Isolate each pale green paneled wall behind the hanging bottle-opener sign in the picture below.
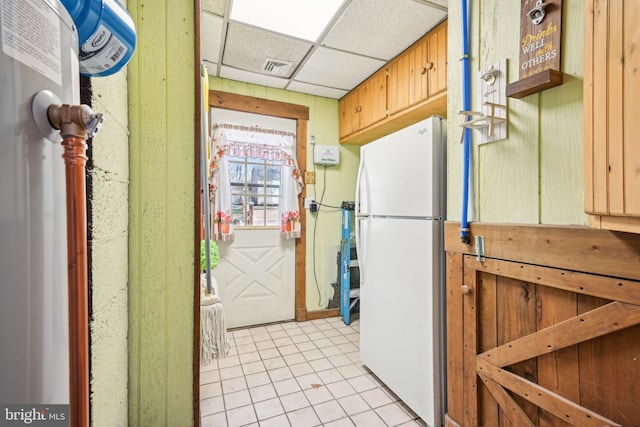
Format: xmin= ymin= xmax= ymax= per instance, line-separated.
xmin=447 ymin=0 xmax=587 ymax=224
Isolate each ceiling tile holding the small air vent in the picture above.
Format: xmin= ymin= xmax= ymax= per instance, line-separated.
xmin=222 ymin=22 xmax=311 ymax=77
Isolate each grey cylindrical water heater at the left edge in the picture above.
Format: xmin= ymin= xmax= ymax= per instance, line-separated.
xmin=0 ymin=0 xmax=80 ymax=405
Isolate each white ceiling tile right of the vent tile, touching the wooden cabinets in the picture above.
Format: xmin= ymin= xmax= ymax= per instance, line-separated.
xmin=295 ymin=47 xmax=385 ymax=90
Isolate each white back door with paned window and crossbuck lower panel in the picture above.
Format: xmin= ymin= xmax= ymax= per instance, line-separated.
xmin=210 ymin=108 xmax=298 ymax=329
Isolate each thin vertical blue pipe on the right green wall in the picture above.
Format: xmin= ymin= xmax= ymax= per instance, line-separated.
xmin=460 ymin=0 xmax=471 ymax=245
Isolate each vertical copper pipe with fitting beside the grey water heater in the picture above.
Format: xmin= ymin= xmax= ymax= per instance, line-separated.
xmin=47 ymin=104 xmax=101 ymax=427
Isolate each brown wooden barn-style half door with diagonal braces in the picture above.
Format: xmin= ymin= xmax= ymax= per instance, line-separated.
xmin=445 ymin=222 xmax=640 ymax=426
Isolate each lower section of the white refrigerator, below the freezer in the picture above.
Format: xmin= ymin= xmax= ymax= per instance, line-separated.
xmin=358 ymin=218 xmax=444 ymax=426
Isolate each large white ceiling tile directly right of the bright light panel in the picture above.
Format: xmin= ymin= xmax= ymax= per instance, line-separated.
xmin=323 ymin=0 xmax=447 ymax=61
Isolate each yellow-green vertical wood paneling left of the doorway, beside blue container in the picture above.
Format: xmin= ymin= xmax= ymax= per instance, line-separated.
xmin=128 ymin=0 xmax=195 ymax=426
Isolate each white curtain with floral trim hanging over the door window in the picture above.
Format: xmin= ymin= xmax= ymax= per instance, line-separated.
xmin=209 ymin=123 xmax=304 ymax=241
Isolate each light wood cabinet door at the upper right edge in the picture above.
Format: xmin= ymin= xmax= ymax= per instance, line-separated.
xmin=584 ymin=0 xmax=640 ymax=232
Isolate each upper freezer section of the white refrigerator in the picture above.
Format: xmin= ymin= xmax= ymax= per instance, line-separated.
xmin=356 ymin=118 xmax=446 ymax=217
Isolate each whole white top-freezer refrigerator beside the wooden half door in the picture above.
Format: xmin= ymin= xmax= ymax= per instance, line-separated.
xmin=355 ymin=116 xmax=446 ymax=426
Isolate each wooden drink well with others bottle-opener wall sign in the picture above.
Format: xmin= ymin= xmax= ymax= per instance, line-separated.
xmin=507 ymin=0 xmax=562 ymax=98
